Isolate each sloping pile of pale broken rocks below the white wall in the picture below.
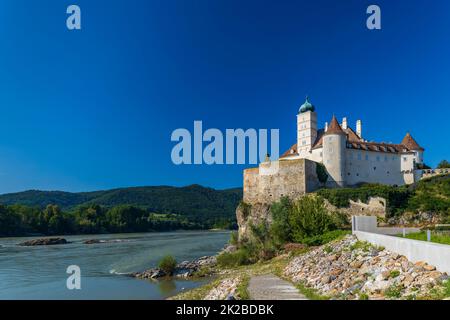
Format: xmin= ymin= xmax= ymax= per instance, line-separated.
xmin=284 ymin=236 xmax=448 ymax=299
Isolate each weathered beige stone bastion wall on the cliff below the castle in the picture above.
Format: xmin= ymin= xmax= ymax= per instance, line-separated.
xmin=244 ymin=159 xmax=320 ymax=204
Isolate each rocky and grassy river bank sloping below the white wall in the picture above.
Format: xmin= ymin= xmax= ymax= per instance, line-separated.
xmin=170 ymin=235 xmax=450 ymax=300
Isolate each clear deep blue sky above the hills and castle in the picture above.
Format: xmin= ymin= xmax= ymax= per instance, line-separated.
xmin=0 ymin=0 xmax=450 ymax=193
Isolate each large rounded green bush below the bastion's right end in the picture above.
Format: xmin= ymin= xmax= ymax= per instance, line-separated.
xmin=289 ymin=196 xmax=336 ymax=242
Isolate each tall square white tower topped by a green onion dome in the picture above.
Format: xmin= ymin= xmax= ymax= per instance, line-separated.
xmin=297 ymin=97 xmax=317 ymax=157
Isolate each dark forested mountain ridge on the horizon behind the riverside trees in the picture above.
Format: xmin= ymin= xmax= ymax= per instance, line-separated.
xmin=0 ymin=185 xmax=242 ymax=221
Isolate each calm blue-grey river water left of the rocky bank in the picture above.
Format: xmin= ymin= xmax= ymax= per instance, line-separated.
xmin=0 ymin=231 xmax=229 ymax=299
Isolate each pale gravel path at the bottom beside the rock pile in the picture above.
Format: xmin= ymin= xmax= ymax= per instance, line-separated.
xmin=248 ymin=274 xmax=308 ymax=300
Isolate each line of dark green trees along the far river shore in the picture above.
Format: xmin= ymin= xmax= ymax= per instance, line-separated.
xmin=0 ymin=204 xmax=236 ymax=237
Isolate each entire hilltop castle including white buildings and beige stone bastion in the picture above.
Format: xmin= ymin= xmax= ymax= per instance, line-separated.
xmin=244 ymin=98 xmax=424 ymax=203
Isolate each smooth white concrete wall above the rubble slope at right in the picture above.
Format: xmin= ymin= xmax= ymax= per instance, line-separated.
xmin=353 ymin=231 xmax=450 ymax=273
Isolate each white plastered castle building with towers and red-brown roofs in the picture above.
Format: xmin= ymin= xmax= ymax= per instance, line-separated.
xmin=281 ymin=100 xmax=424 ymax=186
